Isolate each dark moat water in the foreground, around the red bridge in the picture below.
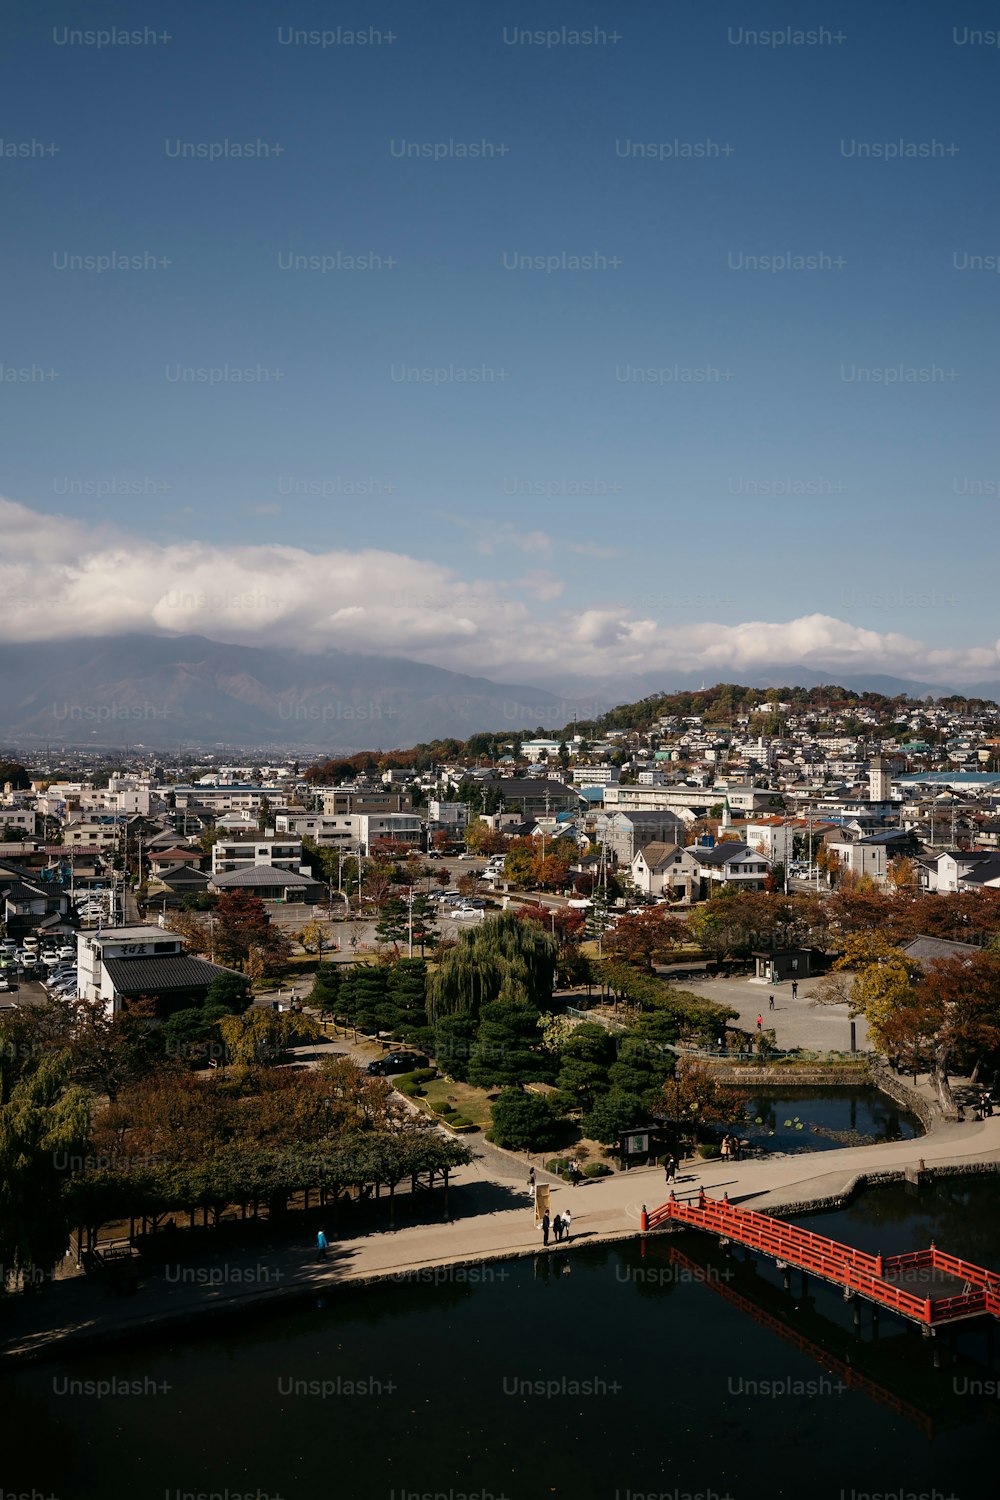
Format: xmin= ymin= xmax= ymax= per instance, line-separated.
xmin=0 ymin=1178 xmax=1000 ymax=1500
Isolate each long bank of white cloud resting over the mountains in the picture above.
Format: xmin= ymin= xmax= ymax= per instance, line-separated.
xmin=0 ymin=500 xmax=1000 ymax=683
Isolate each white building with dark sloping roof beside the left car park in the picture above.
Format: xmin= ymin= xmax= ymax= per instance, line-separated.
xmin=76 ymin=927 xmax=234 ymax=1017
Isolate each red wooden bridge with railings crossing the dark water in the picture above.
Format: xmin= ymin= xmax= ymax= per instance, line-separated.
xmin=640 ymin=1193 xmax=1000 ymax=1332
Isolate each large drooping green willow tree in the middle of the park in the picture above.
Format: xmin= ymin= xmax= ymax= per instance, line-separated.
xmin=427 ymin=912 xmax=558 ymax=1023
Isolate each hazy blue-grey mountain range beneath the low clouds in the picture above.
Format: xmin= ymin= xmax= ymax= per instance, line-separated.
xmin=0 ymin=635 xmax=1000 ymax=755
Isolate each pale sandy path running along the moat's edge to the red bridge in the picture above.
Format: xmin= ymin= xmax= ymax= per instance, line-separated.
xmin=3 ymin=1098 xmax=1000 ymax=1355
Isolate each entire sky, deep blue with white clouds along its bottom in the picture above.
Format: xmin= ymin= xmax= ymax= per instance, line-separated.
xmin=0 ymin=0 xmax=1000 ymax=681
